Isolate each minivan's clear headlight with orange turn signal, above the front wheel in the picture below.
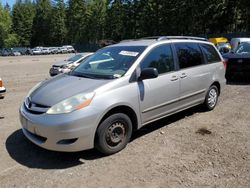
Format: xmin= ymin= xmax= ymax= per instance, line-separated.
xmin=47 ymin=92 xmax=95 ymax=114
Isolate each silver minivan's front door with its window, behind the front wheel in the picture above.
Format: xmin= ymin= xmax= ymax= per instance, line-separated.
xmin=138 ymin=44 xmax=180 ymax=124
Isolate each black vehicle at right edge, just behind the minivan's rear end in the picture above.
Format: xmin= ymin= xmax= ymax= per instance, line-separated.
xmin=223 ymin=41 xmax=250 ymax=80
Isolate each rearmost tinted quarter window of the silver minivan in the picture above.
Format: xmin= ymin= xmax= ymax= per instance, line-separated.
xmin=201 ymin=44 xmax=221 ymax=63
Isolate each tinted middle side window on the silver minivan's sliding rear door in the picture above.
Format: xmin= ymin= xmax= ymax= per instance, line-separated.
xmin=175 ymin=43 xmax=203 ymax=69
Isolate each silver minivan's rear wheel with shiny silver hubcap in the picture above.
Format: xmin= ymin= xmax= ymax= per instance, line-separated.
xmin=203 ymin=85 xmax=219 ymax=111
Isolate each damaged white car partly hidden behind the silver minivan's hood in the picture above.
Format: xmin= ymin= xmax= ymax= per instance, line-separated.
xmin=49 ymin=53 xmax=93 ymax=76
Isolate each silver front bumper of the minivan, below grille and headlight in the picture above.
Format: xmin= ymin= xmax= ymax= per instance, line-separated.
xmin=20 ymin=102 xmax=100 ymax=152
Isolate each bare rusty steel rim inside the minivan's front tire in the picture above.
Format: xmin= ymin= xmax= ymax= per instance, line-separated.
xmin=106 ymin=122 xmax=126 ymax=147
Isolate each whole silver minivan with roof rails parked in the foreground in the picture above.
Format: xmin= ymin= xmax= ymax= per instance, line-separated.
xmin=20 ymin=37 xmax=226 ymax=154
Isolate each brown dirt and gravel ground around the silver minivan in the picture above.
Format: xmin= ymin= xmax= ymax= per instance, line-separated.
xmin=0 ymin=55 xmax=250 ymax=188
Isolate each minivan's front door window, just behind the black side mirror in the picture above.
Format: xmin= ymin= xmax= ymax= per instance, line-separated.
xmin=141 ymin=45 xmax=174 ymax=74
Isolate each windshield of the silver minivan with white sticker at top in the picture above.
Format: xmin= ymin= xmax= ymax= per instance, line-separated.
xmin=71 ymin=46 xmax=146 ymax=79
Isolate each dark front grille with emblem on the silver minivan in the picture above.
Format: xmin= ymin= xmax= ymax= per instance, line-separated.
xmin=24 ymin=97 xmax=50 ymax=115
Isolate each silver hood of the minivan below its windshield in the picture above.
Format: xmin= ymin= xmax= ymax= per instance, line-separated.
xmin=30 ymin=74 xmax=112 ymax=106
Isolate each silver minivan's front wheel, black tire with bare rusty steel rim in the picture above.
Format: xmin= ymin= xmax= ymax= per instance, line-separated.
xmin=95 ymin=113 xmax=132 ymax=155
